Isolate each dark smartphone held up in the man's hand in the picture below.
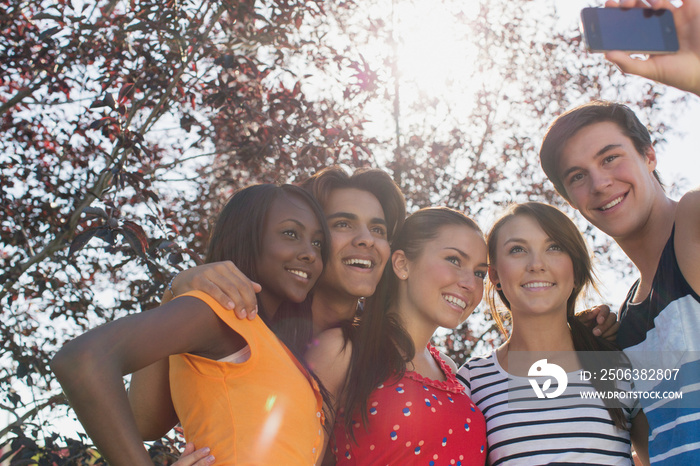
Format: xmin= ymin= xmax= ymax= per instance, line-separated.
xmin=581 ymin=8 xmax=678 ymax=54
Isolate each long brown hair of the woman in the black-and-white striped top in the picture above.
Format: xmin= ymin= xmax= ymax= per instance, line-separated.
xmin=486 ymin=202 xmax=629 ymax=430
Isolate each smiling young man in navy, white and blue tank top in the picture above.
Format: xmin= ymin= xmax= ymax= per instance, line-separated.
xmin=540 ymin=101 xmax=700 ymax=464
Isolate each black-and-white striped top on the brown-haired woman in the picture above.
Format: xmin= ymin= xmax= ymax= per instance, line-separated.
xmin=457 ymin=353 xmax=639 ymax=466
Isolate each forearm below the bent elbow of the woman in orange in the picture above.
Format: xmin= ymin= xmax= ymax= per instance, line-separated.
xmin=51 ymin=342 xmax=153 ymax=466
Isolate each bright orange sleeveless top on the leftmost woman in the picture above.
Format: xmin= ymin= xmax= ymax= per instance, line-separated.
xmin=170 ymin=292 xmax=323 ymax=465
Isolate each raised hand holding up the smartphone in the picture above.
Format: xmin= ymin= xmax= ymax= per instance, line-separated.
xmin=605 ymin=0 xmax=700 ymax=96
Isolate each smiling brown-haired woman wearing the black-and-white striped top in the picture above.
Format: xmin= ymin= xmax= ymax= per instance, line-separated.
xmin=458 ymin=202 xmax=646 ymax=466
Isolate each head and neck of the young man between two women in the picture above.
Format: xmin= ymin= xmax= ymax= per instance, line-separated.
xmin=301 ymin=166 xmax=406 ymax=334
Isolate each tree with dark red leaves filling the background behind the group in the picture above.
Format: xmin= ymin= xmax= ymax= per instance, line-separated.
xmin=0 ymin=0 xmax=688 ymax=464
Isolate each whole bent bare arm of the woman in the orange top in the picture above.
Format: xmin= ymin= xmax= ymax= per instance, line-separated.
xmin=51 ymin=297 xmax=238 ymax=466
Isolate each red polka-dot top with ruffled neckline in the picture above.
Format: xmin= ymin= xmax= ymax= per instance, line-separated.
xmin=331 ymin=345 xmax=486 ymax=466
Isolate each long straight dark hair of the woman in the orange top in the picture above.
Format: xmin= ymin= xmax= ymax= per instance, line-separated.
xmin=206 ymin=184 xmax=330 ymax=355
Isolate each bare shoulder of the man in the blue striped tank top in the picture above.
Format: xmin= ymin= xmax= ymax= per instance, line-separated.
xmin=674 ymin=188 xmax=700 ymax=293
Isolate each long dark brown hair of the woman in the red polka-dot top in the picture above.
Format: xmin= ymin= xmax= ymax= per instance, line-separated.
xmin=343 ymin=207 xmax=482 ymax=437
